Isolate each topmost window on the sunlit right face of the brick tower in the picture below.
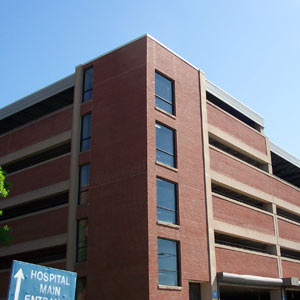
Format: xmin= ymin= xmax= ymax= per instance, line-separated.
xmin=155 ymin=72 xmax=174 ymax=114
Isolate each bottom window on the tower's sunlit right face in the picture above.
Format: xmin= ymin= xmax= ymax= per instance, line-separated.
xmin=157 ymin=238 xmax=180 ymax=286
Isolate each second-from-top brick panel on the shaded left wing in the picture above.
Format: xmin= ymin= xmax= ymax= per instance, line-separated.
xmin=7 ymin=155 xmax=70 ymax=197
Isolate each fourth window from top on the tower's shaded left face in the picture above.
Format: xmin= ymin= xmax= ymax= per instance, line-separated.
xmin=76 ymin=218 xmax=88 ymax=262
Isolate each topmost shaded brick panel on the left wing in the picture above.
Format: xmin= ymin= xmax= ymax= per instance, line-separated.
xmin=0 ymin=107 xmax=72 ymax=156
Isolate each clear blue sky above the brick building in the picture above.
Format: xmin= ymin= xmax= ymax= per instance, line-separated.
xmin=0 ymin=0 xmax=300 ymax=158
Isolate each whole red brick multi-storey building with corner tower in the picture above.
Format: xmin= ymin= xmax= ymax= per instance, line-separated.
xmin=0 ymin=35 xmax=300 ymax=300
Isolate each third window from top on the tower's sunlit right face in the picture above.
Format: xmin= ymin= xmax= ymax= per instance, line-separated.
xmin=156 ymin=178 xmax=177 ymax=224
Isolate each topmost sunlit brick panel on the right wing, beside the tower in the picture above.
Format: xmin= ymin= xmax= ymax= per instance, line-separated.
xmin=207 ymin=102 xmax=267 ymax=154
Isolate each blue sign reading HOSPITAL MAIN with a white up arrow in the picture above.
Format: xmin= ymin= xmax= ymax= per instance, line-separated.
xmin=7 ymin=260 xmax=77 ymax=300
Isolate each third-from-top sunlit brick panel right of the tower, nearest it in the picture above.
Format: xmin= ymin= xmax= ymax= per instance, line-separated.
xmin=213 ymin=196 xmax=274 ymax=235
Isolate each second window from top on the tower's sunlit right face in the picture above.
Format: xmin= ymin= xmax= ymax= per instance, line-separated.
xmin=155 ymin=123 xmax=176 ymax=167
